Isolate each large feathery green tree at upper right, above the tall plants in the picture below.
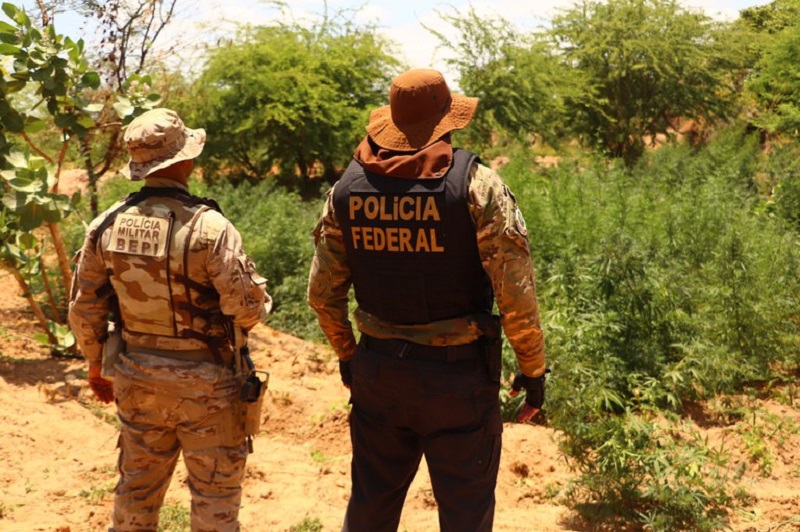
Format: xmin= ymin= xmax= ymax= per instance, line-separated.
xmin=551 ymin=0 xmax=737 ymax=165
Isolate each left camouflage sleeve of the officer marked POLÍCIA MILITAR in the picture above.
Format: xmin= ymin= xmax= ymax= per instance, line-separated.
xmin=68 ymin=219 xmax=114 ymax=364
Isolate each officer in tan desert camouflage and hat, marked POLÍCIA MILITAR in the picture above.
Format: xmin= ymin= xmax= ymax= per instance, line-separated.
xmin=69 ymin=109 xmax=271 ymax=532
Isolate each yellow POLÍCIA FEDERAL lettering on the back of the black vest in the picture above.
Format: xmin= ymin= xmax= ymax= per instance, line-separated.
xmin=347 ymin=193 xmax=445 ymax=253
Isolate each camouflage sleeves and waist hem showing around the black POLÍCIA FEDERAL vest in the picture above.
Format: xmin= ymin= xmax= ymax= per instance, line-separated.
xmin=308 ymin=164 xmax=545 ymax=377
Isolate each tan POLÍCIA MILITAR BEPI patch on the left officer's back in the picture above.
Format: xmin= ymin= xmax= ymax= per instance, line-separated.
xmin=106 ymin=213 xmax=170 ymax=259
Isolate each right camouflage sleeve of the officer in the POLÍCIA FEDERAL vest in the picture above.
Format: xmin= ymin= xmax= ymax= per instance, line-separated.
xmin=469 ymin=165 xmax=545 ymax=377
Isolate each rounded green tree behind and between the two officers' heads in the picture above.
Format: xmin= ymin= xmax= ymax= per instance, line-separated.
xmin=190 ymin=9 xmax=399 ymax=190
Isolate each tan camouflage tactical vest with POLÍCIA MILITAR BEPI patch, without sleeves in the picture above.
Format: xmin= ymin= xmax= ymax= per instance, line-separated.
xmin=92 ymin=187 xmax=227 ymax=351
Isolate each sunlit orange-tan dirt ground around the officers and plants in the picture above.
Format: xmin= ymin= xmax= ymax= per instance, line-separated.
xmin=0 ymin=172 xmax=800 ymax=532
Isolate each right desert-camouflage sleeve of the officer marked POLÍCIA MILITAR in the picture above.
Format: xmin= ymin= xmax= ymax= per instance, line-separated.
xmin=204 ymin=215 xmax=272 ymax=330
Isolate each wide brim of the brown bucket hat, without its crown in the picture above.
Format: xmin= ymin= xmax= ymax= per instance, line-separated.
xmin=366 ymin=94 xmax=478 ymax=151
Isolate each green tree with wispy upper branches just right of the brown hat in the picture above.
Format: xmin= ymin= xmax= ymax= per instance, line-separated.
xmin=427 ymin=8 xmax=573 ymax=152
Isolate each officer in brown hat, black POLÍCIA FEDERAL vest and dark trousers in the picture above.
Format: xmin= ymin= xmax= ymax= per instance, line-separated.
xmin=308 ymin=69 xmax=545 ymax=532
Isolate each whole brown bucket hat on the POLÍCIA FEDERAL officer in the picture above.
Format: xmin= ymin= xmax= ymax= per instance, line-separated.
xmin=367 ymin=68 xmax=478 ymax=151
